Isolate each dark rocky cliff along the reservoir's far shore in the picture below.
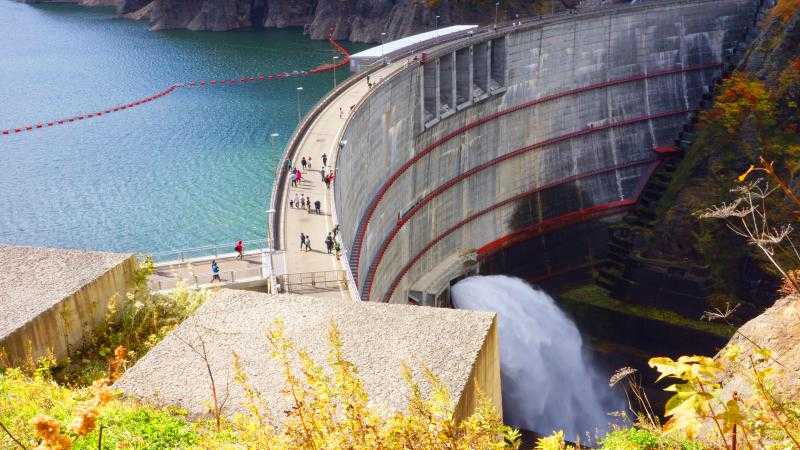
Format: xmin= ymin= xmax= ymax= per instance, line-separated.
xmin=22 ymin=0 xmax=571 ymax=42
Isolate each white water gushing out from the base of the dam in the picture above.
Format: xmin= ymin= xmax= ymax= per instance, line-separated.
xmin=452 ymin=275 xmax=624 ymax=442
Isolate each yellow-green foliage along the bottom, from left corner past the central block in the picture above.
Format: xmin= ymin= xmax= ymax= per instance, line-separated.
xmin=0 ymin=322 xmax=519 ymax=450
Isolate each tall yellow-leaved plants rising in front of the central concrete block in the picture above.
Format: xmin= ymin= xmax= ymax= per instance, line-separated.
xmin=256 ymin=321 xmax=519 ymax=450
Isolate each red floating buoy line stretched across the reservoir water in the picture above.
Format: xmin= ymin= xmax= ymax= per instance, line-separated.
xmin=0 ymin=36 xmax=350 ymax=136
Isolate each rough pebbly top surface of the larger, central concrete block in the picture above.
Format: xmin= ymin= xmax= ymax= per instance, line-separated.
xmin=116 ymin=289 xmax=494 ymax=423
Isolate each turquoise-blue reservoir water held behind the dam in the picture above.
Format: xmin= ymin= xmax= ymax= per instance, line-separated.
xmin=0 ymin=0 xmax=366 ymax=252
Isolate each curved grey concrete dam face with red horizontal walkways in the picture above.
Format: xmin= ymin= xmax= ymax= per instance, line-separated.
xmin=335 ymin=0 xmax=760 ymax=302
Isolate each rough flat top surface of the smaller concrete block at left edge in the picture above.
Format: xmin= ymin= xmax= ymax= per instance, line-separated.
xmin=0 ymin=244 xmax=131 ymax=340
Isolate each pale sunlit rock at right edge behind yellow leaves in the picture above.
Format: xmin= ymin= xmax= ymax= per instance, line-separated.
xmin=722 ymin=295 xmax=800 ymax=399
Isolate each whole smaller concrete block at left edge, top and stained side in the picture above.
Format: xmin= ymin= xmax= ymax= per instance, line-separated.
xmin=0 ymin=245 xmax=136 ymax=366
